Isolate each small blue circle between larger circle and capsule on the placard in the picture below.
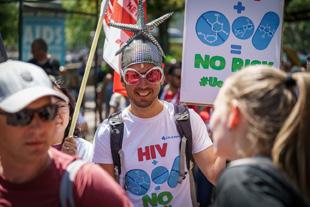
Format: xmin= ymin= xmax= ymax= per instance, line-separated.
xmin=231 ymin=16 xmax=254 ymax=40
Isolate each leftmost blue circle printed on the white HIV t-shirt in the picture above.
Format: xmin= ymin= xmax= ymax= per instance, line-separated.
xmin=125 ymin=170 xmax=151 ymax=196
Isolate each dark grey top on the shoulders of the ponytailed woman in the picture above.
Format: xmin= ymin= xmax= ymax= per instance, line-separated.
xmin=216 ymin=158 xmax=308 ymax=206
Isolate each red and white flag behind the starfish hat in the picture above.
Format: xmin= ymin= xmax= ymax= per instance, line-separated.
xmin=101 ymin=0 xmax=146 ymax=95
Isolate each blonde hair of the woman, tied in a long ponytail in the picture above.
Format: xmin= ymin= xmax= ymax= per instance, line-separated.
xmin=220 ymin=65 xmax=310 ymax=202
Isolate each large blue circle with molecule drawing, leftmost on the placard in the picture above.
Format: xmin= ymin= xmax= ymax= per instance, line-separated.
xmin=196 ymin=11 xmax=230 ymax=46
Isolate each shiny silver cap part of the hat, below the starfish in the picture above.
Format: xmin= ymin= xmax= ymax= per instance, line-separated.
xmin=122 ymin=39 xmax=163 ymax=70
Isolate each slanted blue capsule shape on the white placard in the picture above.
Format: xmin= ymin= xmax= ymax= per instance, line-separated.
xmin=252 ymin=12 xmax=280 ymax=50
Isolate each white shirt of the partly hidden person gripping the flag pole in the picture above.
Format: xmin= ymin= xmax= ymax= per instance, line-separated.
xmin=75 ymin=138 xmax=93 ymax=162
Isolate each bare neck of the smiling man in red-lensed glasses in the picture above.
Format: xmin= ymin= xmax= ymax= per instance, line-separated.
xmin=129 ymin=99 xmax=164 ymax=118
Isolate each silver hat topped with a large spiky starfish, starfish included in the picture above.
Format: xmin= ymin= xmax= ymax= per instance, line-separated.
xmin=110 ymin=0 xmax=173 ymax=69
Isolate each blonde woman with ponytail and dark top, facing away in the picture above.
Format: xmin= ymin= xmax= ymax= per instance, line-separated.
xmin=211 ymin=66 xmax=310 ymax=207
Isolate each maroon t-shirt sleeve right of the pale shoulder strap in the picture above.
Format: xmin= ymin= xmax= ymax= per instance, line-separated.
xmin=74 ymin=163 xmax=132 ymax=207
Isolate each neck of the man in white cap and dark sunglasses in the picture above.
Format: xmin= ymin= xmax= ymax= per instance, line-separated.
xmin=0 ymin=153 xmax=51 ymax=183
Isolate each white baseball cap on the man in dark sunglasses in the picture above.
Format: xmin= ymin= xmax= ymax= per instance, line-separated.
xmin=0 ymin=60 xmax=68 ymax=113
